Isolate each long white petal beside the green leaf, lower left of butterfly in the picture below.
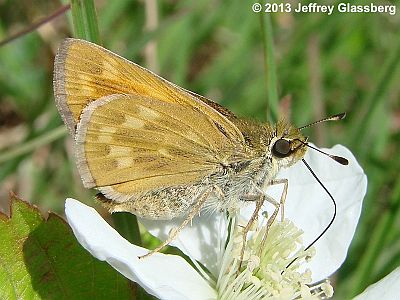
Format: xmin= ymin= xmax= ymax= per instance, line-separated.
xmin=65 ymin=199 xmax=216 ymax=300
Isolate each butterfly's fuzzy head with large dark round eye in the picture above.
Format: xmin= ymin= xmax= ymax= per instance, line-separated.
xmin=269 ymin=120 xmax=307 ymax=168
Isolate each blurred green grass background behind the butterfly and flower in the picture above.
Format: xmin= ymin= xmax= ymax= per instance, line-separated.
xmin=0 ymin=0 xmax=400 ymax=299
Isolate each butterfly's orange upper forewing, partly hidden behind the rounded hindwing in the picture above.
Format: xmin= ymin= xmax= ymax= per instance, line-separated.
xmin=54 ymin=39 xmax=243 ymax=141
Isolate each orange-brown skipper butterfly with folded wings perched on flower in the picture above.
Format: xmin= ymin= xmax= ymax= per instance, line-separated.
xmin=54 ymin=39 xmax=344 ymax=258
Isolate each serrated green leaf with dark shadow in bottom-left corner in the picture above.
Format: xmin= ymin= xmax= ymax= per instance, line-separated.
xmin=0 ymin=198 xmax=133 ymax=300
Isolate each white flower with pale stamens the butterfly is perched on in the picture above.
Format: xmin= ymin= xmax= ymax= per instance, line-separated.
xmin=65 ymin=146 xmax=367 ymax=300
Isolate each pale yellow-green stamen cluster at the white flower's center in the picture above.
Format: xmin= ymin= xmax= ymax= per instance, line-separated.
xmin=216 ymin=219 xmax=333 ymax=300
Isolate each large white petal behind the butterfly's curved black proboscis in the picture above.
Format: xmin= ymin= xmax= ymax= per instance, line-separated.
xmin=244 ymin=145 xmax=367 ymax=282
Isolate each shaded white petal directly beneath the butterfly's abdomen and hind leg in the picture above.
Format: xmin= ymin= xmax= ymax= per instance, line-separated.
xmin=139 ymin=213 xmax=227 ymax=276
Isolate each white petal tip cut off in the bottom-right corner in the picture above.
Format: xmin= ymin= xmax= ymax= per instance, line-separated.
xmin=353 ymin=267 xmax=400 ymax=300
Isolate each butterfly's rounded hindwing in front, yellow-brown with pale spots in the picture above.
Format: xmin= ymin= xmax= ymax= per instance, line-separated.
xmin=76 ymin=94 xmax=243 ymax=200
